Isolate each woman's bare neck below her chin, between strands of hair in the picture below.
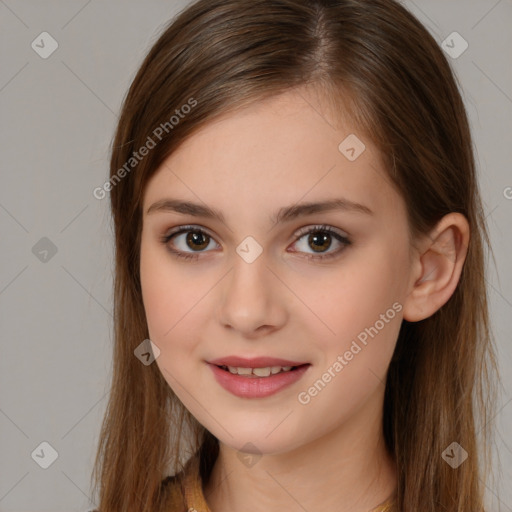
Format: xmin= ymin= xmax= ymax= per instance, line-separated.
xmin=204 ymin=390 xmax=396 ymax=512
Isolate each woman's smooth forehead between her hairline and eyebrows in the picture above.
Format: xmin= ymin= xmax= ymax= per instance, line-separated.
xmin=144 ymin=90 xmax=396 ymax=221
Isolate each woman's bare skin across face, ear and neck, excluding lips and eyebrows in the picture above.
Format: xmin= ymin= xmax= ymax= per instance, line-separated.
xmin=140 ymin=87 xmax=469 ymax=512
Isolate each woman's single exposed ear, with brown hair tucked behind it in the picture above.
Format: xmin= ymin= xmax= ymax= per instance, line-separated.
xmin=403 ymin=213 xmax=469 ymax=322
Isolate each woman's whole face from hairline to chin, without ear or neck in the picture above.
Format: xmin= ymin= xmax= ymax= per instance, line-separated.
xmin=140 ymin=86 xmax=411 ymax=453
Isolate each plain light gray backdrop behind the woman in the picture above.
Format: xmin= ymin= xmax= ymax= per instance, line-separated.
xmin=0 ymin=0 xmax=512 ymax=512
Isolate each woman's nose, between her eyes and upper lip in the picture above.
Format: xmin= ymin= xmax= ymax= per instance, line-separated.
xmin=217 ymin=250 xmax=289 ymax=339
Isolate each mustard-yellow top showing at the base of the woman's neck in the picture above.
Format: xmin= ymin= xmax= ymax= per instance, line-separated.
xmin=163 ymin=456 xmax=395 ymax=512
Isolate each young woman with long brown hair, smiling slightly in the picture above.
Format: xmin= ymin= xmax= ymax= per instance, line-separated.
xmin=90 ymin=0 xmax=495 ymax=512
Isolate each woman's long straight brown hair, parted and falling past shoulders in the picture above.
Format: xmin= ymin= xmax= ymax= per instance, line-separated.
xmin=93 ymin=0 xmax=496 ymax=512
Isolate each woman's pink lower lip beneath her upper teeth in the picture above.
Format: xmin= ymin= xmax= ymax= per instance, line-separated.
xmin=209 ymin=364 xmax=311 ymax=398
